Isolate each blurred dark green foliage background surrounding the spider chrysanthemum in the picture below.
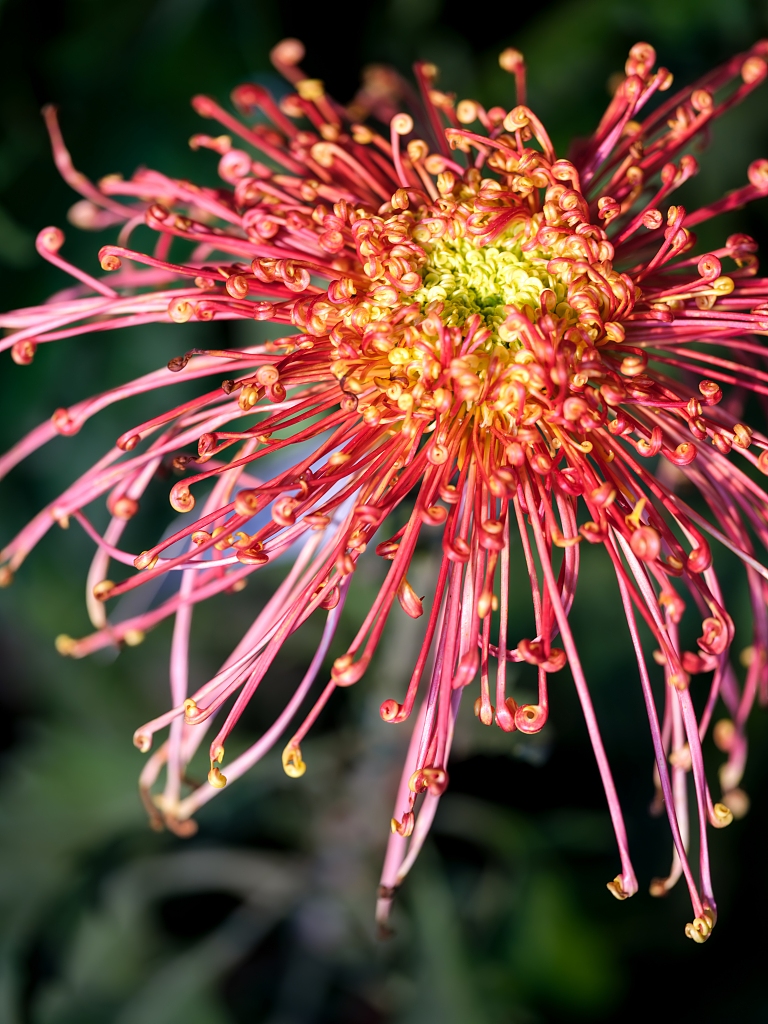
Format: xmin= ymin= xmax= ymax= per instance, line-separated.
xmin=0 ymin=0 xmax=768 ymax=1024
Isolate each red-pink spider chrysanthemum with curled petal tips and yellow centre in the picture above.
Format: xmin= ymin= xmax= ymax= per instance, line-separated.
xmin=0 ymin=40 xmax=768 ymax=942
